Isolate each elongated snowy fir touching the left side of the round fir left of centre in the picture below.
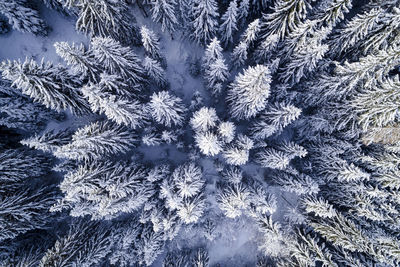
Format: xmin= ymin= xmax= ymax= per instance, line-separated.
xmin=81 ymin=81 xmax=148 ymax=129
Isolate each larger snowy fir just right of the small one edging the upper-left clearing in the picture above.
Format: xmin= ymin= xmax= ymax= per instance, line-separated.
xmin=90 ymin=37 xmax=145 ymax=85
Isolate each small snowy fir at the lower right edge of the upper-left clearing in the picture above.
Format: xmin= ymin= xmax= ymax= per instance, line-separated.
xmin=54 ymin=42 xmax=100 ymax=81
